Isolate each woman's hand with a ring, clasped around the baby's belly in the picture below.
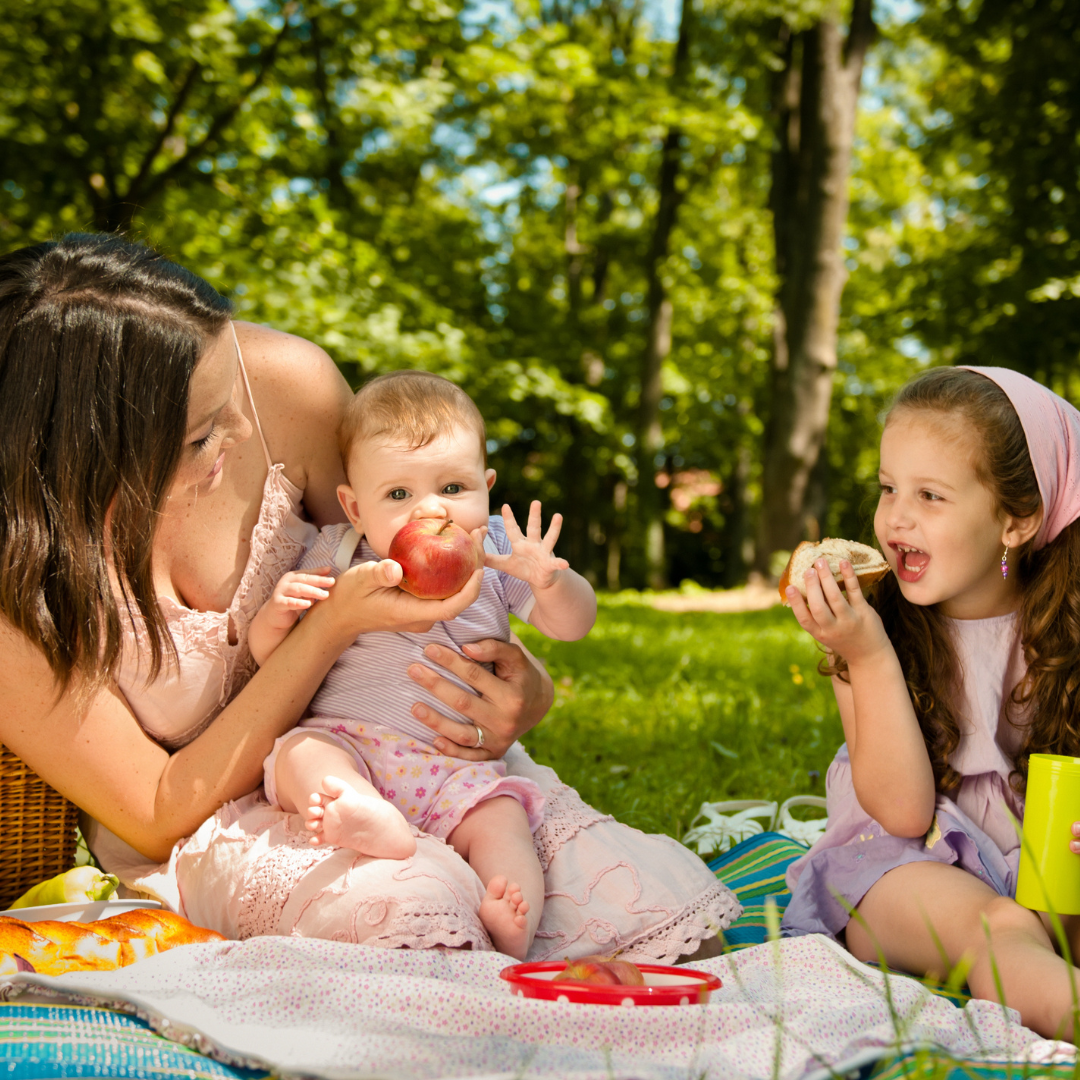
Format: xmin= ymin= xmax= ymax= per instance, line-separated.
xmin=408 ymin=639 xmax=555 ymax=761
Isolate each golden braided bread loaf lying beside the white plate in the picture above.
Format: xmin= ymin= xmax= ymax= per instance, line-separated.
xmin=0 ymin=908 xmax=225 ymax=975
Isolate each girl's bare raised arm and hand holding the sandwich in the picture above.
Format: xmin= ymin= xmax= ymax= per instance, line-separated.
xmin=787 ymin=561 xmax=936 ymax=837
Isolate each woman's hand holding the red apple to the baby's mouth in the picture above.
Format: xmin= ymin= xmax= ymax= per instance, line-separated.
xmin=309 ymin=558 xmax=484 ymax=642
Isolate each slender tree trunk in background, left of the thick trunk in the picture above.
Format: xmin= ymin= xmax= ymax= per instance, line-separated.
xmin=637 ymin=0 xmax=693 ymax=589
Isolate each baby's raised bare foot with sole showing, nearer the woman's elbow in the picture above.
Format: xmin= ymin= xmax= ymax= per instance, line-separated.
xmin=303 ymin=777 xmax=416 ymax=859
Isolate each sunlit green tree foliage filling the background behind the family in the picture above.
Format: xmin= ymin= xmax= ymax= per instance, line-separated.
xmin=0 ymin=0 xmax=1080 ymax=588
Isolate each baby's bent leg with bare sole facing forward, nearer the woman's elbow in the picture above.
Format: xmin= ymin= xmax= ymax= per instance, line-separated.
xmin=274 ymin=731 xmax=416 ymax=859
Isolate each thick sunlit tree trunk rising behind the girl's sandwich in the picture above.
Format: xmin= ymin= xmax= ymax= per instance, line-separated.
xmin=755 ymin=0 xmax=874 ymax=572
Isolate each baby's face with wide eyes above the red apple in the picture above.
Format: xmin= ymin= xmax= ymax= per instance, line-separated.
xmin=338 ymin=427 xmax=495 ymax=558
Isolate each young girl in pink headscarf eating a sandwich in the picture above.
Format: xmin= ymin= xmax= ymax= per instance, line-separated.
xmin=783 ymin=368 xmax=1080 ymax=1038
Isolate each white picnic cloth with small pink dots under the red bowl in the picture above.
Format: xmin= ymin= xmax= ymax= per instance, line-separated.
xmin=3 ymin=936 xmax=1074 ymax=1080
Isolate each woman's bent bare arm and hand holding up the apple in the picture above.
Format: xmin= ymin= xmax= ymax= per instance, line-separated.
xmin=0 ymin=561 xmax=483 ymax=861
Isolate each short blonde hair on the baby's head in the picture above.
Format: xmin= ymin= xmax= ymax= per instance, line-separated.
xmin=338 ymin=372 xmax=487 ymax=468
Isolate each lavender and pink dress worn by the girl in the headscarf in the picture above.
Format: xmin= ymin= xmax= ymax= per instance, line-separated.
xmin=782 ymin=615 xmax=1025 ymax=937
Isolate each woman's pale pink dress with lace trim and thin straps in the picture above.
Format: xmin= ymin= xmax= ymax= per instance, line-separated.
xmin=84 ymin=330 xmax=740 ymax=962
